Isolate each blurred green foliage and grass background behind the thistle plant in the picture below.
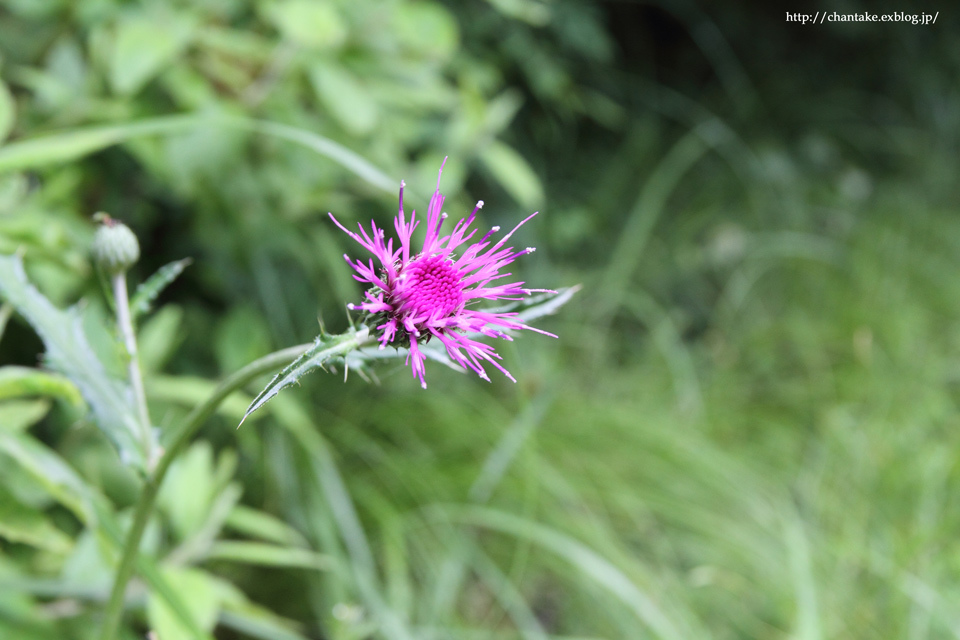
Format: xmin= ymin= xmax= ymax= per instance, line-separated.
xmin=0 ymin=0 xmax=960 ymax=640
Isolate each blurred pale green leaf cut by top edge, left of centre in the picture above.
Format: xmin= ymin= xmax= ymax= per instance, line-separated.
xmin=264 ymin=0 xmax=348 ymax=49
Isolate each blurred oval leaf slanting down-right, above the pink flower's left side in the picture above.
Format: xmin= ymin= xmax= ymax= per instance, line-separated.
xmin=310 ymin=62 xmax=377 ymax=136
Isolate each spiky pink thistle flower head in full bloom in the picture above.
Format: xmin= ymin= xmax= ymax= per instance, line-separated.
xmin=329 ymin=158 xmax=557 ymax=389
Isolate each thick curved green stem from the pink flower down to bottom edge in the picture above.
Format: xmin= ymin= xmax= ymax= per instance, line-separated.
xmin=100 ymin=342 xmax=313 ymax=640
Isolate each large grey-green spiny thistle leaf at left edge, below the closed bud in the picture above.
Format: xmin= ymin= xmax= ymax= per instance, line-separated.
xmin=0 ymin=256 xmax=159 ymax=469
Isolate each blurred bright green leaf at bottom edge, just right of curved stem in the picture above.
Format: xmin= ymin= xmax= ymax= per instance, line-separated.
xmin=147 ymin=567 xmax=221 ymax=640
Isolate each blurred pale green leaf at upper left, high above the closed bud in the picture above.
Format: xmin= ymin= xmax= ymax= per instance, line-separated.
xmin=110 ymin=13 xmax=193 ymax=95
